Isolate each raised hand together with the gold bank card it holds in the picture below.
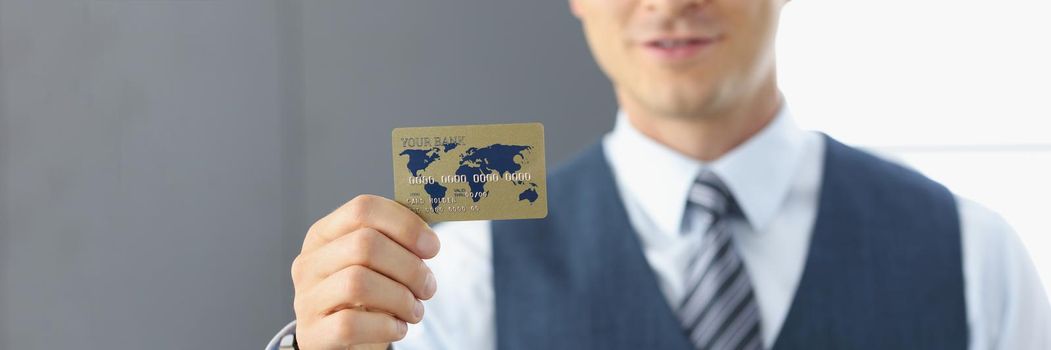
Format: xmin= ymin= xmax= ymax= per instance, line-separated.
xmin=292 ymin=123 xmax=548 ymax=349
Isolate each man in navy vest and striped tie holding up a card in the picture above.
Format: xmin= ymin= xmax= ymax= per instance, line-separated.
xmin=270 ymin=0 xmax=1051 ymax=350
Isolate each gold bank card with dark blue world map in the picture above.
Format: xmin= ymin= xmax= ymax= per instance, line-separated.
xmin=391 ymin=123 xmax=548 ymax=222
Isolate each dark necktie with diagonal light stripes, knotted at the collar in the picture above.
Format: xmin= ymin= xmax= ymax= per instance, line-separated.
xmin=678 ymin=172 xmax=762 ymax=350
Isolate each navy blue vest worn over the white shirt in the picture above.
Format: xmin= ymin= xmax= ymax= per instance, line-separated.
xmin=492 ymin=137 xmax=968 ymax=350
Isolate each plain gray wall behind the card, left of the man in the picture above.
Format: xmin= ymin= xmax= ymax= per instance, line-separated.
xmin=0 ymin=0 xmax=615 ymax=350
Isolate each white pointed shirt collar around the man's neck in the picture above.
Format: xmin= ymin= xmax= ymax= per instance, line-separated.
xmin=603 ymin=107 xmax=805 ymax=233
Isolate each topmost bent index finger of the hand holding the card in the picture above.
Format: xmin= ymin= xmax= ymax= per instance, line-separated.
xmin=302 ymin=194 xmax=440 ymax=259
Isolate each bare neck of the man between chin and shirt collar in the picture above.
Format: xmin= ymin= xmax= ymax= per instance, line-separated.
xmin=618 ymin=77 xmax=781 ymax=162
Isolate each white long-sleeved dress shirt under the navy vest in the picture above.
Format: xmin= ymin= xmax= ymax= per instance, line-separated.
xmin=270 ymin=108 xmax=1051 ymax=350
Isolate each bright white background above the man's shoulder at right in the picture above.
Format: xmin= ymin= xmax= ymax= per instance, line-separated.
xmin=778 ymin=0 xmax=1051 ymax=297
